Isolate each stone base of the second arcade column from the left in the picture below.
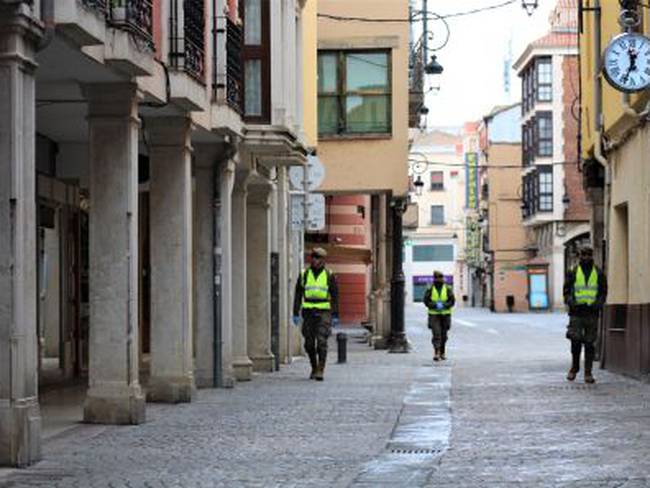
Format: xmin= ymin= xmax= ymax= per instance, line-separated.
xmin=84 ymin=386 xmax=145 ymax=425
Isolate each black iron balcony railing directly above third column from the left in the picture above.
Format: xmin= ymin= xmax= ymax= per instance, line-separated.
xmin=169 ymin=0 xmax=205 ymax=83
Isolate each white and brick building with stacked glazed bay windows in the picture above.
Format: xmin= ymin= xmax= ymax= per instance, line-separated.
xmin=514 ymin=0 xmax=590 ymax=310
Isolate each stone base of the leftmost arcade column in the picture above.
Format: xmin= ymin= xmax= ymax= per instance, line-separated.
xmin=0 ymin=398 xmax=41 ymax=468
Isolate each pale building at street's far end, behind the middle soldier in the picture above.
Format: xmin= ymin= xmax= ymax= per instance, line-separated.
xmin=404 ymin=128 xmax=467 ymax=304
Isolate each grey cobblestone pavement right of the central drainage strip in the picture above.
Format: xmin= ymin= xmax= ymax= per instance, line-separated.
xmin=428 ymin=312 xmax=650 ymax=488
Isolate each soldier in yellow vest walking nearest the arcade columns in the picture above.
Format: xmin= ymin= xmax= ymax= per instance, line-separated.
xmin=293 ymin=248 xmax=339 ymax=381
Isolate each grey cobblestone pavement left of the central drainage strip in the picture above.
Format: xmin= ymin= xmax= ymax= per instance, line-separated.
xmin=0 ymin=316 xmax=436 ymax=488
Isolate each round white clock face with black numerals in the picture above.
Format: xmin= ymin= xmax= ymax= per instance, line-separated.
xmin=603 ymin=33 xmax=650 ymax=92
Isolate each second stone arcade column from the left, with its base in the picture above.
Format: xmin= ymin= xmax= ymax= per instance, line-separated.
xmin=84 ymin=83 xmax=145 ymax=424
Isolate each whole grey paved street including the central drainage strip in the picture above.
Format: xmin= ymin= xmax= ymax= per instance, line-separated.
xmin=0 ymin=307 xmax=650 ymax=488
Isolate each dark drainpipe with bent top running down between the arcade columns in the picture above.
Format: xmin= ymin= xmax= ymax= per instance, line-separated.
xmin=212 ymin=139 xmax=237 ymax=388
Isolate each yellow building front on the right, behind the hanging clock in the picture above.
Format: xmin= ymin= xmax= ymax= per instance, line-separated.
xmin=580 ymin=0 xmax=650 ymax=376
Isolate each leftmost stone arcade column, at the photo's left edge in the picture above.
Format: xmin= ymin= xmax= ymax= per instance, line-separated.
xmin=0 ymin=2 xmax=42 ymax=467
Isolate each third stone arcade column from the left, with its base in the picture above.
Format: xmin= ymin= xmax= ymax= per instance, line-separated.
xmin=147 ymin=117 xmax=195 ymax=403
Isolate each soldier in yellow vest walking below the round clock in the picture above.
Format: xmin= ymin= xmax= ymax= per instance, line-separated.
xmin=564 ymin=247 xmax=607 ymax=384
